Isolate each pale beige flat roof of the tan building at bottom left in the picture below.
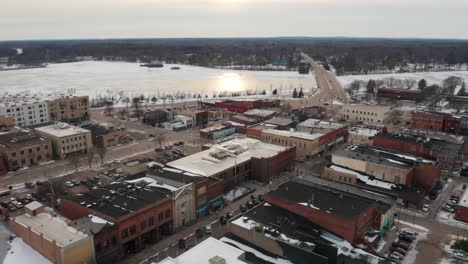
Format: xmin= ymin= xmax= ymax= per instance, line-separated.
xmin=14 ymin=213 xmax=88 ymax=247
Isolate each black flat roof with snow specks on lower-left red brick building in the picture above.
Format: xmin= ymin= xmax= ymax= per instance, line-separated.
xmin=70 ymin=182 xmax=172 ymax=219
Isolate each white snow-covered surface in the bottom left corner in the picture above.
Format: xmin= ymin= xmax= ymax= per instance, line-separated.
xmin=3 ymin=237 xmax=52 ymax=264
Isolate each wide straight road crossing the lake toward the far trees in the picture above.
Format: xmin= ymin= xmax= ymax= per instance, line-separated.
xmin=302 ymin=53 xmax=348 ymax=102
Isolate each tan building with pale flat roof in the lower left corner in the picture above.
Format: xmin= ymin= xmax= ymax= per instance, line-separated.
xmin=10 ymin=202 xmax=95 ymax=264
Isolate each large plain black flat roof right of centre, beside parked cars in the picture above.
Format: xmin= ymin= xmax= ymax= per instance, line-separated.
xmin=267 ymin=181 xmax=374 ymax=220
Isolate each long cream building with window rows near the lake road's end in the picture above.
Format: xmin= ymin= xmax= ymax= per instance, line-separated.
xmin=340 ymin=104 xmax=392 ymax=124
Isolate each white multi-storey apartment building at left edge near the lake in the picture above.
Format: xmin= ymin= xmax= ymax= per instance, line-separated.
xmin=0 ymin=97 xmax=49 ymax=127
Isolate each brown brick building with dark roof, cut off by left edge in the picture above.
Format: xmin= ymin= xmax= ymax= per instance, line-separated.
xmin=0 ymin=131 xmax=53 ymax=171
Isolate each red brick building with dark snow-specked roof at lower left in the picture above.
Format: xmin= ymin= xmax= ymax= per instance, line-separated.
xmin=61 ymin=182 xmax=173 ymax=259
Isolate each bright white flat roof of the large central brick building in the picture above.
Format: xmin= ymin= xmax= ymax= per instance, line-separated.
xmin=167 ymin=138 xmax=288 ymax=176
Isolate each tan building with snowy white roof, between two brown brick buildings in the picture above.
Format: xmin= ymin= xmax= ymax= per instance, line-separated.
xmin=35 ymin=123 xmax=92 ymax=159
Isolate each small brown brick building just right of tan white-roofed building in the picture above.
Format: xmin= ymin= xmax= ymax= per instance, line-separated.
xmin=81 ymin=123 xmax=129 ymax=148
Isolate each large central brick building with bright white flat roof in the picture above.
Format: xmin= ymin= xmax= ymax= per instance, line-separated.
xmin=167 ymin=138 xmax=296 ymax=189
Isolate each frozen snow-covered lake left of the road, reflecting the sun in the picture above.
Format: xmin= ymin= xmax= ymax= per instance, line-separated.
xmin=0 ymin=61 xmax=316 ymax=97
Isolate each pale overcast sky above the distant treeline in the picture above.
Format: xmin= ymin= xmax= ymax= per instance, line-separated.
xmin=0 ymin=0 xmax=468 ymax=40
